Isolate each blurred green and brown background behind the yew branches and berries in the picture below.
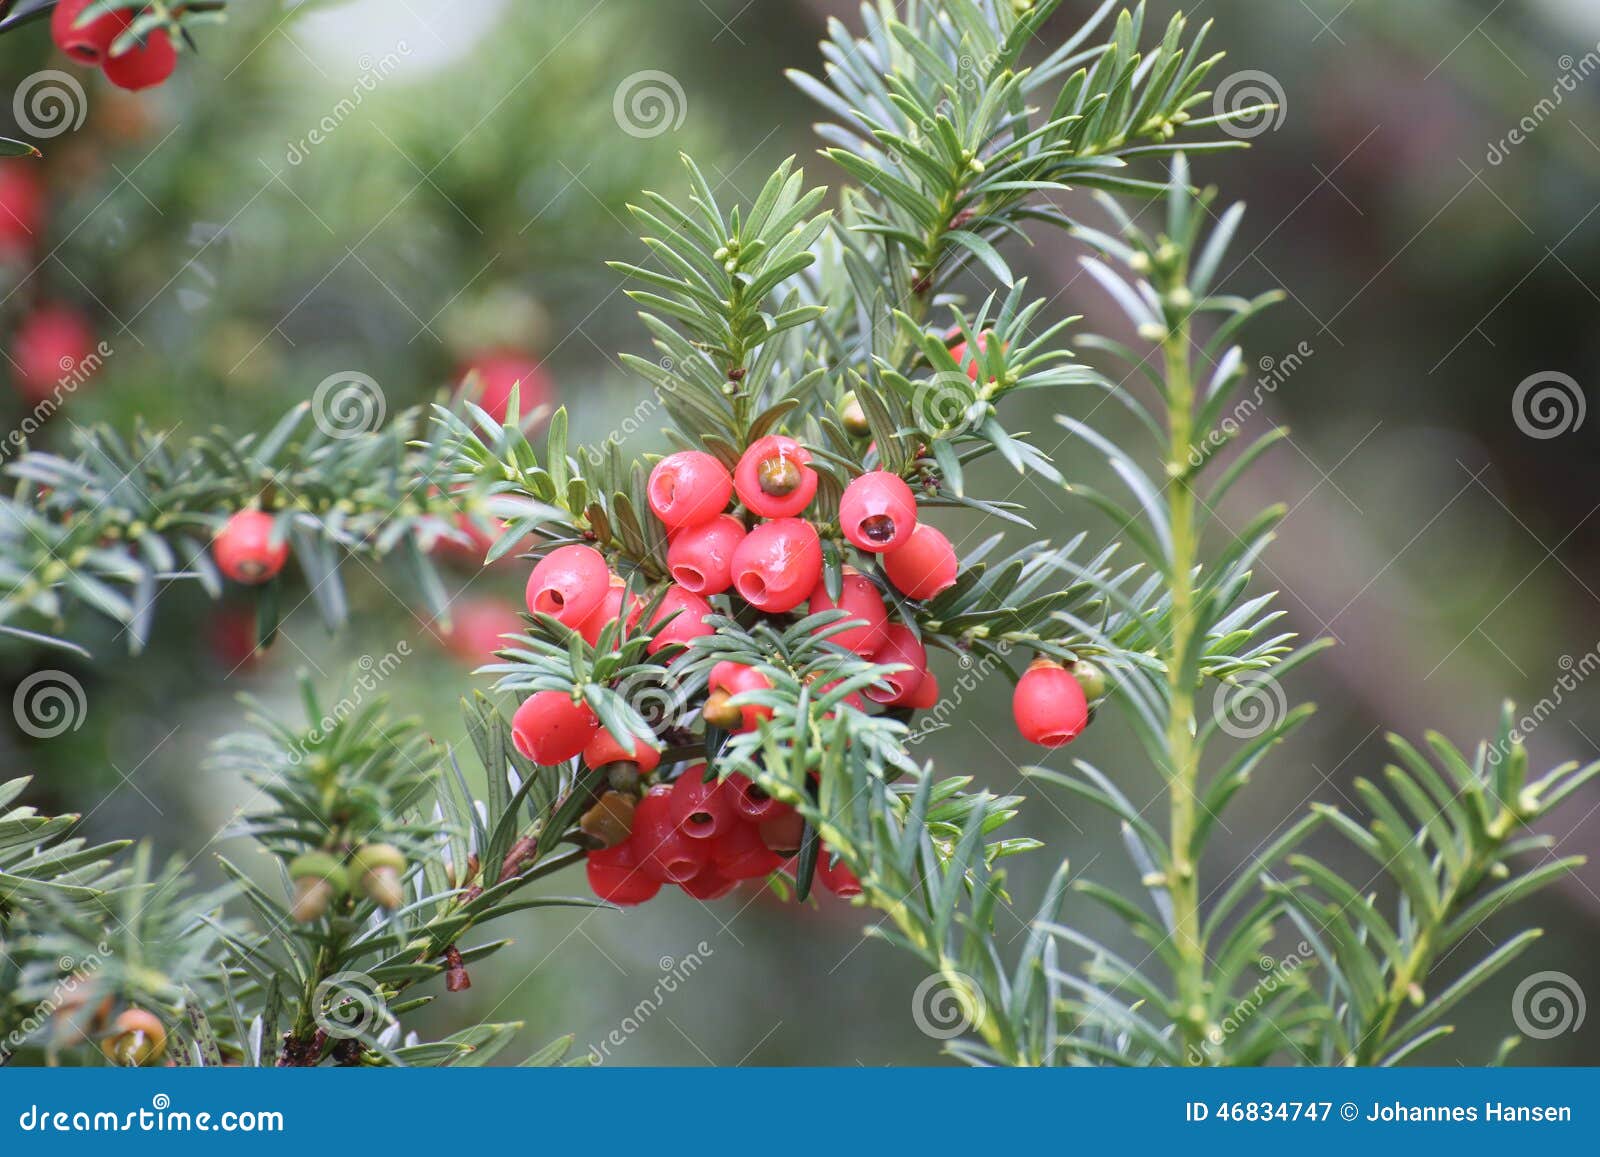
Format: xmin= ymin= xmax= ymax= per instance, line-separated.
xmin=0 ymin=0 xmax=1600 ymax=1064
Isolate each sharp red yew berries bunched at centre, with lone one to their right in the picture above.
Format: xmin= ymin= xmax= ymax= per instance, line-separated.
xmin=512 ymin=434 xmax=1104 ymax=904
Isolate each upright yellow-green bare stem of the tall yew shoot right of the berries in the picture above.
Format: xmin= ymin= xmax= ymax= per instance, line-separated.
xmin=1163 ymin=322 xmax=1208 ymax=1059
